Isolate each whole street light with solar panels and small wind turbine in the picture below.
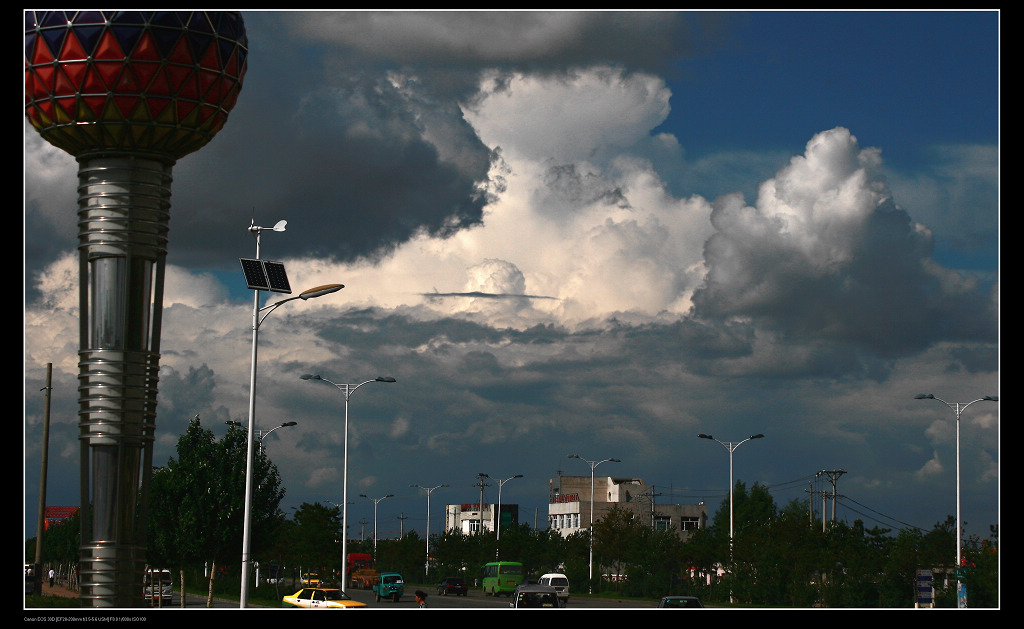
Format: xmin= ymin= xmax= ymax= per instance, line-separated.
xmin=239 ymin=220 xmax=345 ymax=607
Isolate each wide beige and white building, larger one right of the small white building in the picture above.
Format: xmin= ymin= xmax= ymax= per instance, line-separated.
xmin=548 ymin=476 xmax=708 ymax=539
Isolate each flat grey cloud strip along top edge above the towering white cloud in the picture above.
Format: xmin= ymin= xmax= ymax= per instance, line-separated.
xmin=283 ymin=11 xmax=724 ymax=89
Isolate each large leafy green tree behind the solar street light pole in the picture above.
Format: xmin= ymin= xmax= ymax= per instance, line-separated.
xmin=146 ymin=415 xmax=285 ymax=593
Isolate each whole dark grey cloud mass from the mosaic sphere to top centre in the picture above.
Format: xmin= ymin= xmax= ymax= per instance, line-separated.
xmin=157 ymin=11 xmax=719 ymax=267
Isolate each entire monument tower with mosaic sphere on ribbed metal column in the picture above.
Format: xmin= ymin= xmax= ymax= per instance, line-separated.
xmin=25 ymin=11 xmax=249 ymax=607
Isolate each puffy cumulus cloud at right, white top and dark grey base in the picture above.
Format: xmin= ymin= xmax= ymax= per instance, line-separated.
xmin=694 ymin=128 xmax=995 ymax=355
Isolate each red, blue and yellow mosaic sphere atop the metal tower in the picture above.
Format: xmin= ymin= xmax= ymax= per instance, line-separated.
xmin=25 ymin=11 xmax=249 ymax=160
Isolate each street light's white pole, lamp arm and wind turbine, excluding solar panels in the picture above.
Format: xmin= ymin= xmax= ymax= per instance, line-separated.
xmin=239 ymin=220 xmax=345 ymax=607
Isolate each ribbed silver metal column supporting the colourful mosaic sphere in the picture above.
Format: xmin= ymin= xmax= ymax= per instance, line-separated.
xmin=78 ymin=154 xmax=173 ymax=607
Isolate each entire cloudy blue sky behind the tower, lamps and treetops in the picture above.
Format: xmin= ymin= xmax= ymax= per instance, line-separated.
xmin=25 ymin=11 xmax=999 ymax=549
